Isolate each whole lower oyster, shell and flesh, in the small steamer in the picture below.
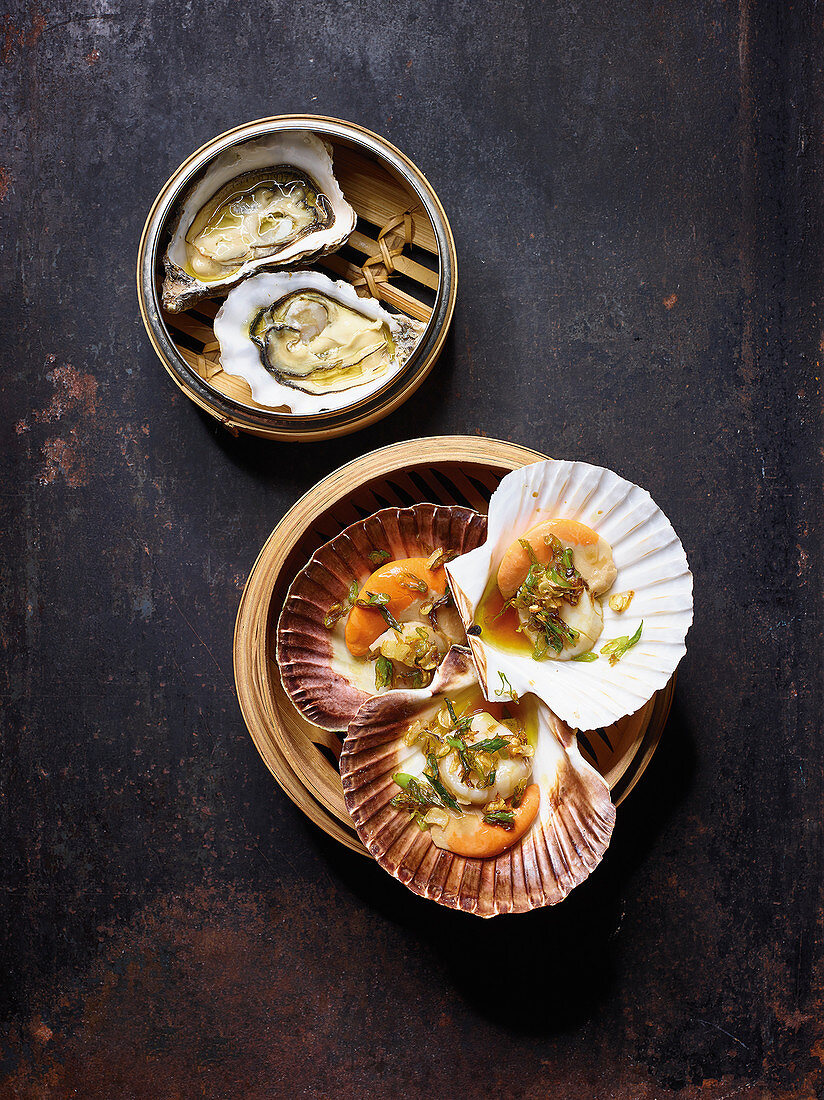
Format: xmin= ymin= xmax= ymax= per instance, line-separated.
xmin=215 ymin=271 xmax=426 ymax=415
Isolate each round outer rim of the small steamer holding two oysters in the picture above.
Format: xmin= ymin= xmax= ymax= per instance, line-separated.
xmin=136 ymin=114 xmax=458 ymax=442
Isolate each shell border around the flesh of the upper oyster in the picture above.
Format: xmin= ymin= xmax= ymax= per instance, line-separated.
xmin=163 ymin=130 xmax=356 ymax=314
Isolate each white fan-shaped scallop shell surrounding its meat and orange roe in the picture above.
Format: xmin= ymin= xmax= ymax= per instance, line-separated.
xmin=447 ymin=459 xmax=692 ymax=729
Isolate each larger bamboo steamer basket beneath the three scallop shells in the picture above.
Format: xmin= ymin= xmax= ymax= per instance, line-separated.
xmin=234 ymin=436 xmax=674 ymax=855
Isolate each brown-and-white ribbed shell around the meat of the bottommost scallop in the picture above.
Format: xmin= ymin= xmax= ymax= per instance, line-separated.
xmin=340 ymin=646 xmax=615 ymax=916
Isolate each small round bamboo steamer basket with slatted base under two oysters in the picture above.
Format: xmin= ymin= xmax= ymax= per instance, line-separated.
xmin=138 ymin=114 xmax=458 ymax=442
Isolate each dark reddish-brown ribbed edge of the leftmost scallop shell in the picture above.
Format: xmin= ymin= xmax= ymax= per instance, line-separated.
xmin=277 ymin=504 xmax=486 ymax=729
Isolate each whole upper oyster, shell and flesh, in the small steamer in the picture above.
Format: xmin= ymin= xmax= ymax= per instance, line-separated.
xmin=163 ymin=130 xmax=356 ymax=312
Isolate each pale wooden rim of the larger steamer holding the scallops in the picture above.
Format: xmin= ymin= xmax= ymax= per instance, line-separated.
xmin=233 ymin=436 xmax=675 ymax=856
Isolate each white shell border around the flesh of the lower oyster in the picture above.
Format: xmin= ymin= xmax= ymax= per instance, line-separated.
xmin=215 ymin=271 xmax=426 ymax=415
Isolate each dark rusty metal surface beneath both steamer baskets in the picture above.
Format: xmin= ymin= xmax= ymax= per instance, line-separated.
xmin=0 ymin=0 xmax=824 ymax=1100
